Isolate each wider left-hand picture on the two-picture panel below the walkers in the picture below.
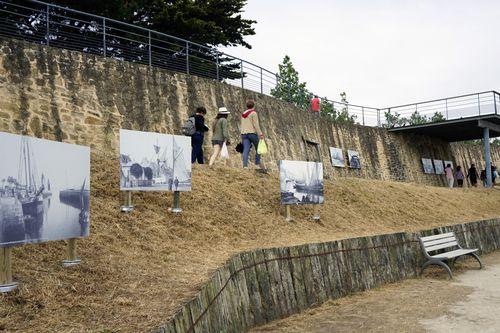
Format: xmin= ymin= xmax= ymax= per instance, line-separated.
xmin=120 ymin=129 xmax=175 ymax=191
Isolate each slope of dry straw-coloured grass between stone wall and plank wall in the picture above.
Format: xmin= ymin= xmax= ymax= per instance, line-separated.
xmin=0 ymin=155 xmax=500 ymax=332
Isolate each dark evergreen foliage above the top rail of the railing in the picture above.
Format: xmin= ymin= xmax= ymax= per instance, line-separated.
xmin=49 ymin=0 xmax=256 ymax=48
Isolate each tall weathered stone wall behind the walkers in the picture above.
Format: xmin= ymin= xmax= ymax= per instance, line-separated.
xmin=0 ymin=38 xmax=500 ymax=185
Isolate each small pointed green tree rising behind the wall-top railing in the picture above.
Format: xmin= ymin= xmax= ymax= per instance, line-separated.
xmin=271 ymin=55 xmax=313 ymax=110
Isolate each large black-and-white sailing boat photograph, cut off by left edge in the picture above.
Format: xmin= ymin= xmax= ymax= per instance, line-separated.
xmin=0 ymin=132 xmax=90 ymax=247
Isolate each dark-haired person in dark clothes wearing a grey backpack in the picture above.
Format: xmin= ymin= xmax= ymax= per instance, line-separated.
xmin=182 ymin=106 xmax=208 ymax=164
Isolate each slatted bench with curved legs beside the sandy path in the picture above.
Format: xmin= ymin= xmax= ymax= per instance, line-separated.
xmin=419 ymin=232 xmax=483 ymax=279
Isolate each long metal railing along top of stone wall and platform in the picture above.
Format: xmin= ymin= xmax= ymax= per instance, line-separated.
xmin=0 ymin=0 xmax=500 ymax=126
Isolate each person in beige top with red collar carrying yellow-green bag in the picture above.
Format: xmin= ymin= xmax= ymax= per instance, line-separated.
xmin=240 ymin=100 xmax=265 ymax=170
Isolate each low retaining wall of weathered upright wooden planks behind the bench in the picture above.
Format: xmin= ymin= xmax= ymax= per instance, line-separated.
xmin=157 ymin=219 xmax=500 ymax=333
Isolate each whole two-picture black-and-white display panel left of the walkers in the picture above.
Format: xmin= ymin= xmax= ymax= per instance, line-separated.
xmin=120 ymin=129 xmax=191 ymax=192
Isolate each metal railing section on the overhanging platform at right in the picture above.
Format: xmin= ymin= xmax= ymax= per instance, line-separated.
xmin=380 ymin=91 xmax=500 ymax=127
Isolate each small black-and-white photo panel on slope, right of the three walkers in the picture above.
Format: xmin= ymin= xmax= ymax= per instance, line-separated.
xmin=280 ymin=161 xmax=324 ymax=205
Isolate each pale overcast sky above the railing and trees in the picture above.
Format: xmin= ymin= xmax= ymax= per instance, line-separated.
xmin=225 ymin=0 xmax=500 ymax=108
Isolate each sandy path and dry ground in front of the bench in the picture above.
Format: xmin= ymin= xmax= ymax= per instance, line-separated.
xmin=252 ymin=252 xmax=500 ymax=333
